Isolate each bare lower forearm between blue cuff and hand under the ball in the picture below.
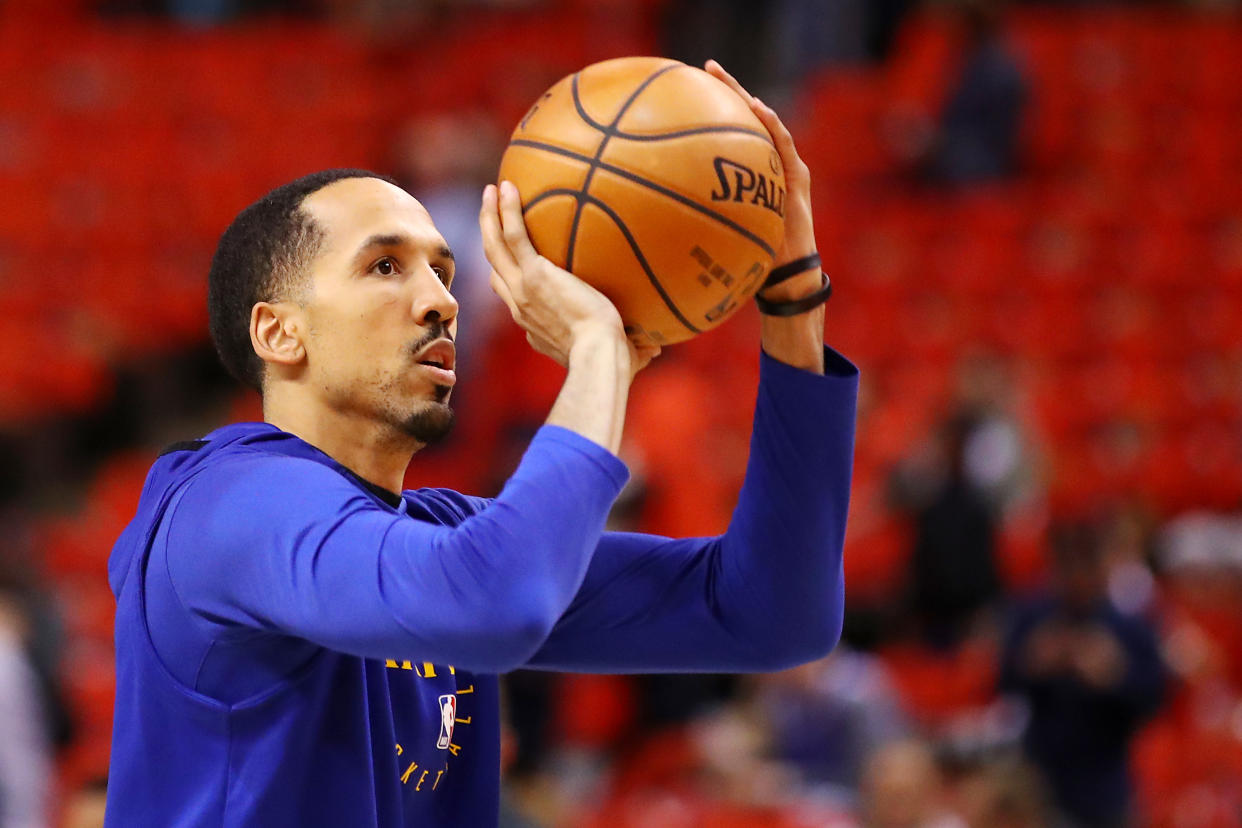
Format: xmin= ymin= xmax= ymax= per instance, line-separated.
xmin=546 ymin=330 xmax=631 ymax=454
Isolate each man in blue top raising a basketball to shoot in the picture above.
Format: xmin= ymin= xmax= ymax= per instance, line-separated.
xmin=108 ymin=63 xmax=857 ymax=828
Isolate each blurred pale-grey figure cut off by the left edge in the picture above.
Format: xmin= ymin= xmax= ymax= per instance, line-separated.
xmin=0 ymin=575 xmax=52 ymax=828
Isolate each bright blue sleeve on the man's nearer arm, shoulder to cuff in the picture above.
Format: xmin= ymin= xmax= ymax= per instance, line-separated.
xmin=162 ymin=427 xmax=626 ymax=672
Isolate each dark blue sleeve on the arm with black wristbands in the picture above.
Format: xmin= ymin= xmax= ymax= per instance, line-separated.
xmin=529 ymin=351 xmax=858 ymax=673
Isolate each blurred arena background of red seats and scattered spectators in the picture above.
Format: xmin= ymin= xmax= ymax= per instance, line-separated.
xmin=0 ymin=0 xmax=1242 ymax=828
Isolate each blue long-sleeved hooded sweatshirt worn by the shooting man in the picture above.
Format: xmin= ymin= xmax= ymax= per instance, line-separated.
xmin=106 ymin=351 xmax=857 ymax=828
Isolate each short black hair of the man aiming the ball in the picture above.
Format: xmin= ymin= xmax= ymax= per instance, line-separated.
xmin=207 ymin=169 xmax=396 ymax=391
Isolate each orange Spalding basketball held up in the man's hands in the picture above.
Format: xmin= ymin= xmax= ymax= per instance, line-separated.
xmin=501 ymin=57 xmax=785 ymax=345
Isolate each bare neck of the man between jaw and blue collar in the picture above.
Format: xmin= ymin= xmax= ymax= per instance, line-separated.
xmin=263 ymin=386 xmax=422 ymax=493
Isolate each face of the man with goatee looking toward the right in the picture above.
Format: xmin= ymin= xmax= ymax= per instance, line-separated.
xmin=295 ymin=179 xmax=457 ymax=443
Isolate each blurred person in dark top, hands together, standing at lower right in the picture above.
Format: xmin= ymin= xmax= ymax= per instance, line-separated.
xmin=1000 ymin=525 xmax=1165 ymax=828
